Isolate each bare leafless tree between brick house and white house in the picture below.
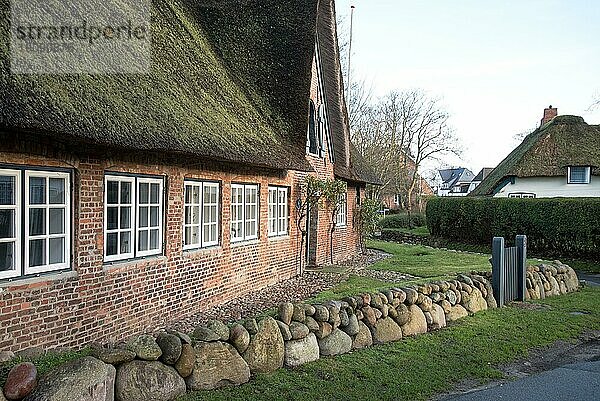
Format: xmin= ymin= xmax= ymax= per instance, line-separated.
xmin=352 ymin=90 xmax=460 ymax=211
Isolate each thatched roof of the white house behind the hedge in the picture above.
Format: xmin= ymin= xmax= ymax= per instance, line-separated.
xmin=470 ymin=116 xmax=600 ymax=196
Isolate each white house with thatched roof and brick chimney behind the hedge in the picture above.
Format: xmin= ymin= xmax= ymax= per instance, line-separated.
xmin=471 ymin=106 xmax=600 ymax=198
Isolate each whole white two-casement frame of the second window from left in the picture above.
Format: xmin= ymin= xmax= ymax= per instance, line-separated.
xmin=103 ymin=172 xmax=165 ymax=262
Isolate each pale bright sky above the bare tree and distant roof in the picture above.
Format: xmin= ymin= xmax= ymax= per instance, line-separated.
xmin=336 ymin=0 xmax=600 ymax=174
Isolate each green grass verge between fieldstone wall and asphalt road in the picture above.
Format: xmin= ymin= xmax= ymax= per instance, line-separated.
xmin=180 ymin=288 xmax=600 ymax=401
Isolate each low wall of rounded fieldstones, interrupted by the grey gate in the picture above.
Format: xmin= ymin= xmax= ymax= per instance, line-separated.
xmin=0 ymin=263 xmax=578 ymax=401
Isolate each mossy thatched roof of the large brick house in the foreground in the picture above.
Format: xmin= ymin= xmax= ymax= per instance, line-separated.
xmin=0 ymin=0 xmax=317 ymax=170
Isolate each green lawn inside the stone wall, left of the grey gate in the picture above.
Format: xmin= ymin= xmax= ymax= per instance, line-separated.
xmin=369 ymin=241 xmax=491 ymax=277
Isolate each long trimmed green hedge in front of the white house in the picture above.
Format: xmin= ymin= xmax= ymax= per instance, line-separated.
xmin=427 ymin=197 xmax=600 ymax=260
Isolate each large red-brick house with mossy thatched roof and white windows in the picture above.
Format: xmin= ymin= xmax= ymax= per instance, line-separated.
xmin=0 ymin=0 xmax=376 ymax=351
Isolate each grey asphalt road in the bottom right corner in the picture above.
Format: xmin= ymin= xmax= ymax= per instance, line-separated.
xmin=444 ymin=361 xmax=600 ymax=401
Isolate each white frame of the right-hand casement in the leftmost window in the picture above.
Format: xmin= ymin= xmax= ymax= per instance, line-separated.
xmin=23 ymin=170 xmax=71 ymax=275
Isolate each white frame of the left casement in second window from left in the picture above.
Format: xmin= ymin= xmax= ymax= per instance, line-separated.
xmin=103 ymin=174 xmax=137 ymax=262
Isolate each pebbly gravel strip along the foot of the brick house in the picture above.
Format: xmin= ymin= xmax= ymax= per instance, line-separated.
xmin=169 ymin=249 xmax=396 ymax=333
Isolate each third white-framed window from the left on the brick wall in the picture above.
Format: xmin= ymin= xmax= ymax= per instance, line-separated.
xmin=183 ymin=181 xmax=220 ymax=249
